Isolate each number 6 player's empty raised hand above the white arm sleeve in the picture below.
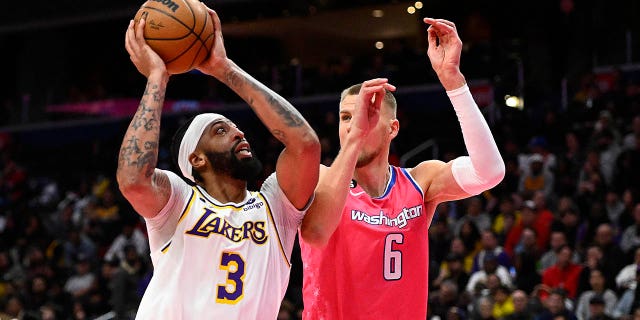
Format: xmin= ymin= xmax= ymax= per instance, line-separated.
xmin=424 ymin=18 xmax=464 ymax=90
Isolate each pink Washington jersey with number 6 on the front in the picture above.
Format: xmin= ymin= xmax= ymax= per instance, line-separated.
xmin=301 ymin=166 xmax=433 ymax=320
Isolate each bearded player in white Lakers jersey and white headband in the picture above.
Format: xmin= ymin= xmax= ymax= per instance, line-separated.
xmin=117 ymin=10 xmax=320 ymax=320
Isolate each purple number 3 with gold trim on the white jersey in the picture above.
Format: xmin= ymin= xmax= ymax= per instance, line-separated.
xmin=216 ymin=252 xmax=244 ymax=304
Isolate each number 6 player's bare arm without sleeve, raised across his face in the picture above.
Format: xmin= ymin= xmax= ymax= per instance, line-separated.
xmin=300 ymin=78 xmax=395 ymax=247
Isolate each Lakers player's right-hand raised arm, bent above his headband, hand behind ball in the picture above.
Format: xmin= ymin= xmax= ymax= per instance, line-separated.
xmin=198 ymin=9 xmax=320 ymax=208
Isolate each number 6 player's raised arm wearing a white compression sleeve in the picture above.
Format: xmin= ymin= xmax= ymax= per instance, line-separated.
xmin=411 ymin=18 xmax=505 ymax=202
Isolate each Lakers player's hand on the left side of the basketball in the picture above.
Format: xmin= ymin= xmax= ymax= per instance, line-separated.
xmin=124 ymin=19 xmax=169 ymax=78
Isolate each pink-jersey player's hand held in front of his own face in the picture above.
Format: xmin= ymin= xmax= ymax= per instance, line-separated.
xmin=349 ymin=78 xmax=396 ymax=138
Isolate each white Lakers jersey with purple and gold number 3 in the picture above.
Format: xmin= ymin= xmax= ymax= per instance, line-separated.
xmin=136 ymin=171 xmax=303 ymax=320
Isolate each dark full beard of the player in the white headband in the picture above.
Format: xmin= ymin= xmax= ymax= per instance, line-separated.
xmin=207 ymin=144 xmax=262 ymax=182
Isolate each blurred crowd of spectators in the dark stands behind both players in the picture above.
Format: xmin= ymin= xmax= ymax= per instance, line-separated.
xmin=0 ymin=63 xmax=640 ymax=320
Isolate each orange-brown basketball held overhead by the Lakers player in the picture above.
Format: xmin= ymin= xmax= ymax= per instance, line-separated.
xmin=134 ymin=0 xmax=214 ymax=74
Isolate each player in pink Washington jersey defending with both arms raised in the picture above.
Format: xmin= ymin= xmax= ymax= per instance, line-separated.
xmin=300 ymin=18 xmax=505 ymax=320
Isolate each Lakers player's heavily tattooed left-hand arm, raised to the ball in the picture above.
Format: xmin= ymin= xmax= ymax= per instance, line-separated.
xmin=116 ymin=20 xmax=171 ymax=218
